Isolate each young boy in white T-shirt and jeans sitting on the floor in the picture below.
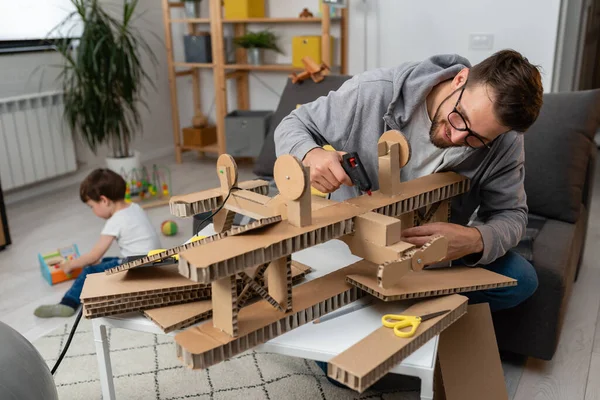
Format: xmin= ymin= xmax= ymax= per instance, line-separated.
xmin=34 ymin=169 xmax=161 ymax=318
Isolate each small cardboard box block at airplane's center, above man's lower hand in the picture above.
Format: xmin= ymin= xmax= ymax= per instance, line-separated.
xmin=354 ymin=211 xmax=402 ymax=246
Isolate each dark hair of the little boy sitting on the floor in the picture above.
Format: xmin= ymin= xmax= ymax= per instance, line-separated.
xmin=79 ymin=168 xmax=127 ymax=203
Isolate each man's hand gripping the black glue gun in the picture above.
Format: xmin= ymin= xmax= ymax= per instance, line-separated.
xmin=302 ymin=147 xmax=353 ymax=193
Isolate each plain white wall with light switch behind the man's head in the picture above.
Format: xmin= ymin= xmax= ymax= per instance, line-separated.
xmin=350 ymin=0 xmax=561 ymax=91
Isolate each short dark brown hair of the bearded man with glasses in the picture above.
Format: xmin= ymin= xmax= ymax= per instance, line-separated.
xmin=469 ymin=49 xmax=544 ymax=132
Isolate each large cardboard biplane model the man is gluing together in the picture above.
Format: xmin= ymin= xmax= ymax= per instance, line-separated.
xmin=107 ymin=131 xmax=516 ymax=391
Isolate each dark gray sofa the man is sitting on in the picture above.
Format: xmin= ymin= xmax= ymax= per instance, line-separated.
xmin=254 ymin=76 xmax=600 ymax=360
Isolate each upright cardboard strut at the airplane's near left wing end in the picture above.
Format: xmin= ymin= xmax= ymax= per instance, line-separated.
xmin=212 ymin=275 xmax=238 ymax=337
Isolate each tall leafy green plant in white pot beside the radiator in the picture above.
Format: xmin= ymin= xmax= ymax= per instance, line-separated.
xmin=50 ymin=0 xmax=157 ymax=173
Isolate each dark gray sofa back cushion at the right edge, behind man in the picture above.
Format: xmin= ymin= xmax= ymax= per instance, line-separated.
xmin=524 ymin=89 xmax=600 ymax=223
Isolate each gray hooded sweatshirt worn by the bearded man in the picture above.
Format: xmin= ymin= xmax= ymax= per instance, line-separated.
xmin=275 ymin=55 xmax=528 ymax=265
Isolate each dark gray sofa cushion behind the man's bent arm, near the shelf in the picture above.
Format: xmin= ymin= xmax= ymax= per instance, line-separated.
xmin=253 ymin=75 xmax=351 ymax=178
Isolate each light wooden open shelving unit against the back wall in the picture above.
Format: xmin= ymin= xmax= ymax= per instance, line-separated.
xmin=160 ymin=0 xmax=349 ymax=164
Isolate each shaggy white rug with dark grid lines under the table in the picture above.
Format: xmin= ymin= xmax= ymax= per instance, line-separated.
xmin=33 ymin=318 xmax=420 ymax=400
